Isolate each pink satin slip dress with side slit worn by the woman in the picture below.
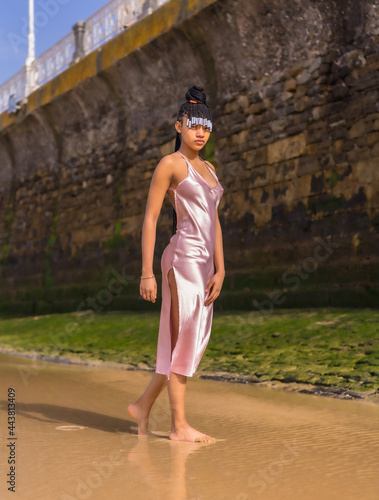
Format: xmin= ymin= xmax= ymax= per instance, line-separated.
xmin=155 ymin=152 xmax=224 ymax=379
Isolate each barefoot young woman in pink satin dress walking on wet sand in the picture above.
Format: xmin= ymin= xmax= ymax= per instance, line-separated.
xmin=128 ymin=85 xmax=225 ymax=442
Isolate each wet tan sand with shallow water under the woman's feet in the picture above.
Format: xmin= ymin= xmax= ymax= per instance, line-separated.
xmin=0 ymin=354 xmax=379 ymax=500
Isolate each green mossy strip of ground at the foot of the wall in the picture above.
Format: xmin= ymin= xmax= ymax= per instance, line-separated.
xmin=0 ymin=308 xmax=379 ymax=391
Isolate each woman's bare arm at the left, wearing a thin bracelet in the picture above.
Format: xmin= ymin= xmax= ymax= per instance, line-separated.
xmin=140 ymin=155 xmax=174 ymax=302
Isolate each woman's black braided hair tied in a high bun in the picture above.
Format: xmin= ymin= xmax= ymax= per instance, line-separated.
xmin=172 ymin=85 xmax=212 ymax=235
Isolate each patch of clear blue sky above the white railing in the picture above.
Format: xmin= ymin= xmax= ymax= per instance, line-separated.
xmin=0 ymin=0 xmax=112 ymax=85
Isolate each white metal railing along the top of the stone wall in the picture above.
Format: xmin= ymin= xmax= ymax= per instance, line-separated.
xmin=0 ymin=0 xmax=167 ymax=113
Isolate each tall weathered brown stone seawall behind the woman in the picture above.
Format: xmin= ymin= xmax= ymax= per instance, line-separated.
xmin=0 ymin=0 xmax=379 ymax=313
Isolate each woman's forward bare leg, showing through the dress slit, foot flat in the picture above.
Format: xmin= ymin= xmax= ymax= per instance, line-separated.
xmin=167 ymin=269 xmax=212 ymax=442
